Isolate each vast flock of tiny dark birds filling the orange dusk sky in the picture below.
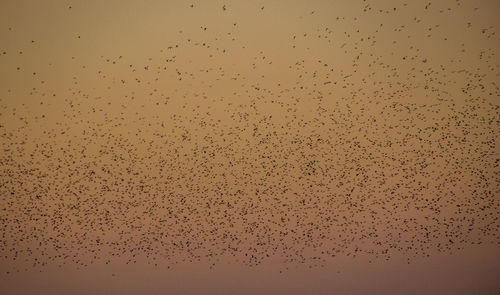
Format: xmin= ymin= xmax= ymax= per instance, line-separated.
xmin=0 ymin=1 xmax=500 ymax=275
